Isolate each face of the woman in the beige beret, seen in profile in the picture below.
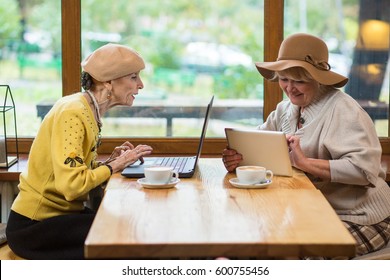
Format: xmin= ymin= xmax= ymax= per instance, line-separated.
xmin=110 ymin=72 xmax=144 ymax=107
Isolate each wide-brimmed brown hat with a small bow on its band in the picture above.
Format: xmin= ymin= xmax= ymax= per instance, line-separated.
xmin=255 ymin=33 xmax=348 ymax=87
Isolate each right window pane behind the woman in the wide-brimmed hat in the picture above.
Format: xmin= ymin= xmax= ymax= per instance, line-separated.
xmin=284 ymin=0 xmax=390 ymax=137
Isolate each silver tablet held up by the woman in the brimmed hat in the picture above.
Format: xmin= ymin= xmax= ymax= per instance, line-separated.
xmin=225 ymin=128 xmax=292 ymax=176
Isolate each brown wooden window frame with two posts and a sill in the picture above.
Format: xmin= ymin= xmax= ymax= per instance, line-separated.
xmin=12 ymin=0 xmax=390 ymax=156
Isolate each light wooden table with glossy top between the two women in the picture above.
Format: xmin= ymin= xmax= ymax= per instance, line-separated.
xmin=85 ymin=158 xmax=355 ymax=259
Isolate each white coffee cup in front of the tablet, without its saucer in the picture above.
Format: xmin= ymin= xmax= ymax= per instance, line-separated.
xmin=236 ymin=165 xmax=274 ymax=184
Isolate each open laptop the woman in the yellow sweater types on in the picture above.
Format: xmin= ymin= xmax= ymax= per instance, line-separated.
xmin=122 ymin=96 xmax=214 ymax=178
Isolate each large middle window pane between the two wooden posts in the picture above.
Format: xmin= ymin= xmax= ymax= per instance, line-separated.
xmin=81 ymin=0 xmax=264 ymax=137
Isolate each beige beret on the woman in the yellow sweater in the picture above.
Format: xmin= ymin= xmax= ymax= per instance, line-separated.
xmin=81 ymin=43 xmax=145 ymax=82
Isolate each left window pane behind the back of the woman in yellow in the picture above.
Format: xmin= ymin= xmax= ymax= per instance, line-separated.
xmin=0 ymin=0 xmax=62 ymax=137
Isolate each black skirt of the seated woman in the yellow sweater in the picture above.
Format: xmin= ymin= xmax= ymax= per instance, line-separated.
xmin=6 ymin=208 xmax=96 ymax=260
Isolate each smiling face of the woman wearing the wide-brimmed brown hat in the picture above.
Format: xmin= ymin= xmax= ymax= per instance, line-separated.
xmin=277 ymin=68 xmax=319 ymax=108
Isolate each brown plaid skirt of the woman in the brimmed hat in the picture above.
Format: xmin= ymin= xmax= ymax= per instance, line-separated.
xmin=342 ymin=217 xmax=390 ymax=256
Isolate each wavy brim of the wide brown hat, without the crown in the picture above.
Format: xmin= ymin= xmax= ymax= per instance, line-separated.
xmin=255 ymin=60 xmax=348 ymax=87
